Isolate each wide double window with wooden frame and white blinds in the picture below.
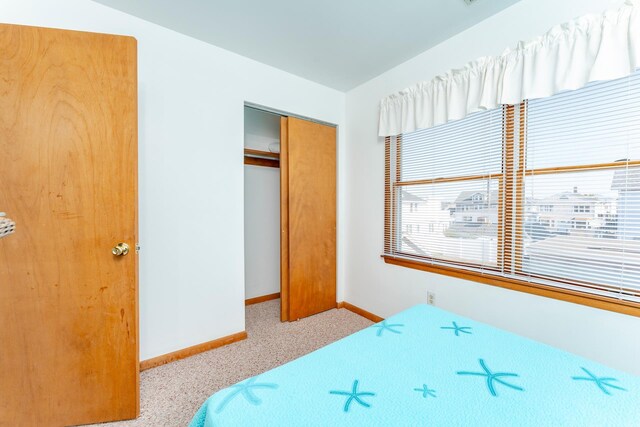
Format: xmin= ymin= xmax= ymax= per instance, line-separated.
xmin=385 ymin=71 xmax=640 ymax=311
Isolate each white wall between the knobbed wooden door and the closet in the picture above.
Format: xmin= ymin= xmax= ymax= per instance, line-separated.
xmin=0 ymin=0 xmax=345 ymax=359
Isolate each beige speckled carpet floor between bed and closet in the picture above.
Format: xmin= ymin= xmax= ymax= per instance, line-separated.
xmin=101 ymin=300 xmax=372 ymax=427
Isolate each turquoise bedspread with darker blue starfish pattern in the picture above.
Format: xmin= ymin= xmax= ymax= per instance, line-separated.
xmin=190 ymin=305 xmax=640 ymax=427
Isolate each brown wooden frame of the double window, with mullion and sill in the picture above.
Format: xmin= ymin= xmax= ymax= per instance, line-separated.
xmin=382 ymin=101 xmax=640 ymax=317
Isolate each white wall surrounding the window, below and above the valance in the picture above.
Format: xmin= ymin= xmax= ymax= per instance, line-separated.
xmin=344 ymin=0 xmax=640 ymax=374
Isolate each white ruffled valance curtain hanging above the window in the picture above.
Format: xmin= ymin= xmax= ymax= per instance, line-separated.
xmin=379 ymin=0 xmax=640 ymax=136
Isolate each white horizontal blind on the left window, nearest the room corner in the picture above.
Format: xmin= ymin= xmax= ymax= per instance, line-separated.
xmin=387 ymin=108 xmax=504 ymax=269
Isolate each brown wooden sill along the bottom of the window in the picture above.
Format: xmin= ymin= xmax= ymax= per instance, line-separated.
xmin=382 ymin=255 xmax=640 ymax=317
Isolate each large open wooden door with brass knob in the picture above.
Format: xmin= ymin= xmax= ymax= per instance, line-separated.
xmin=0 ymin=25 xmax=139 ymax=426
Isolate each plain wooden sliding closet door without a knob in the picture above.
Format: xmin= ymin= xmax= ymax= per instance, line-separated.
xmin=280 ymin=117 xmax=336 ymax=320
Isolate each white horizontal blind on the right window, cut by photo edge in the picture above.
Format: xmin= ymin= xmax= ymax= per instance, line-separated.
xmin=516 ymin=72 xmax=640 ymax=300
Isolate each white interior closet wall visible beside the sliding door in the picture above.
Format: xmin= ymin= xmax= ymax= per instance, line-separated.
xmin=244 ymin=108 xmax=280 ymax=299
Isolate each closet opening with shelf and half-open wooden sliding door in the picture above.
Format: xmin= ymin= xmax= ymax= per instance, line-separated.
xmin=244 ymin=105 xmax=336 ymax=321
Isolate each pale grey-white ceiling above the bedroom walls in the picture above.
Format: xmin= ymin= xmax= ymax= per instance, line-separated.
xmin=95 ymin=0 xmax=519 ymax=91
